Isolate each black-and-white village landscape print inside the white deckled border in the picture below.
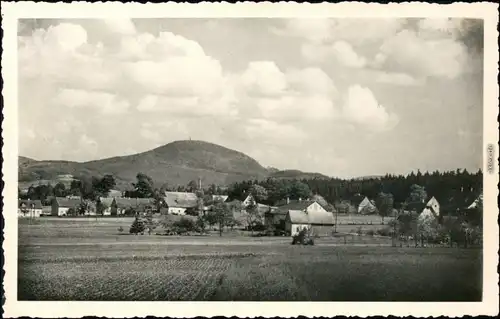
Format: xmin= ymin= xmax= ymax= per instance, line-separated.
xmin=2 ymin=1 xmax=498 ymax=315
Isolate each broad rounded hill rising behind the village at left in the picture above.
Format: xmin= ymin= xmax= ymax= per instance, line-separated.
xmin=19 ymin=141 xmax=268 ymax=189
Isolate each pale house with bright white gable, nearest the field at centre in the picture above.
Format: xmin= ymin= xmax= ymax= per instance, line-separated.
xmin=278 ymin=201 xmax=335 ymax=236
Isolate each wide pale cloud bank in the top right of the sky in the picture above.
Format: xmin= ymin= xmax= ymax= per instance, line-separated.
xmin=274 ymin=18 xmax=477 ymax=83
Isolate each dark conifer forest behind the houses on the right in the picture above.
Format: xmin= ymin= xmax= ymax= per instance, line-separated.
xmin=229 ymin=170 xmax=483 ymax=214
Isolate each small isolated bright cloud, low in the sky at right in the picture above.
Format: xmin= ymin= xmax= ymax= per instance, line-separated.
xmin=343 ymin=85 xmax=398 ymax=131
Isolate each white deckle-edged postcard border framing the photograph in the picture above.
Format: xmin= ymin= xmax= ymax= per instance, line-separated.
xmin=2 ymin=2 xmax=499 ymax=317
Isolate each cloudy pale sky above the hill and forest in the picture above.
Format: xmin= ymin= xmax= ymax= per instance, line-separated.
xmin=18 ymin=18 xmax=483 ymax=178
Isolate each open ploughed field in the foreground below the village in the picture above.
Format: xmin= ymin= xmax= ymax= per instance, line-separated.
xmin=18 ymin=218 xmax=482 ymax=301
